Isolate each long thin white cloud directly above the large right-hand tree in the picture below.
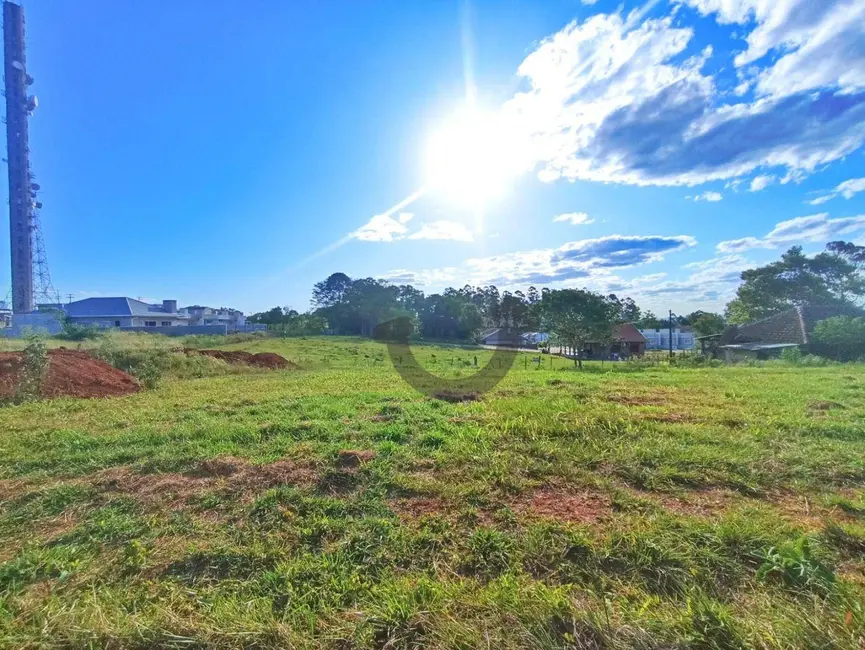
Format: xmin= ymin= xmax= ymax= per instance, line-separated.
xmin=717 ymin=212 xmax=865 ymax=253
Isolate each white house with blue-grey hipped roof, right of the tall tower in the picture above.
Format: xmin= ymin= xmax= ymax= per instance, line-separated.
xmin=62 ymin=298 xmax=189 ymax=328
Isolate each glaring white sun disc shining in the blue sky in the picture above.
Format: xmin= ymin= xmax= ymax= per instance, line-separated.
xmin=425 ymin=107 xmax=526 ymax=210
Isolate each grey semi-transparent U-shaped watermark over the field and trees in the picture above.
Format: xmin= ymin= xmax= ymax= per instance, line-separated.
xmin=374 ymin=316 xmax=520 ymax=402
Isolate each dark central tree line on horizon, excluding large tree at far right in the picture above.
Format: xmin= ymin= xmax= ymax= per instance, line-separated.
xmin=249 ymin=273 xmax=723 ymax=350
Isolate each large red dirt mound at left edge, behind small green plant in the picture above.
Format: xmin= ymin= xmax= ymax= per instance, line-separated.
xmin=0 ymin=349 xmax=141 ymax=397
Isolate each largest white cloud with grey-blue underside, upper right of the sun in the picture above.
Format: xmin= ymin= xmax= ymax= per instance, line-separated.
xmin=503 ymin=5 xmax=865 ymax=185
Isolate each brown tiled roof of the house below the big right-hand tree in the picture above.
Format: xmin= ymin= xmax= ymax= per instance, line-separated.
xmin=721 ymin=305 xmax=863 ymax=345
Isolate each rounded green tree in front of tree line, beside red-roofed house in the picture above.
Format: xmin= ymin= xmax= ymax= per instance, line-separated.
xmin=541 ymin=289 xmax=621 ymax=368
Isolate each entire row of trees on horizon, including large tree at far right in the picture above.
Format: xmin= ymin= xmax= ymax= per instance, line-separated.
xmin=249 ymin=241 xmax=865 ymax=350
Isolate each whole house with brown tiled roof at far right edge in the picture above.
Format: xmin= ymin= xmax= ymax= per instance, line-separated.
xmin=718 ymin=305 xmax=865 ymax=362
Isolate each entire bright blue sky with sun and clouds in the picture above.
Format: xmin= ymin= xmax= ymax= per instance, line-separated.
xmin=0 ymin=0 xmax=865 ymax=313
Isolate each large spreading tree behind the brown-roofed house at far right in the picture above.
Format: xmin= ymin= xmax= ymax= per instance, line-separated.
xmin=727 ymin=242 xmax=865 ymax=324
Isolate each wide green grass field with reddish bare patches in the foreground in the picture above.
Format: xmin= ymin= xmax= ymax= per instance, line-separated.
xmin=0 ymin=339 xmax=865 ymax=650
